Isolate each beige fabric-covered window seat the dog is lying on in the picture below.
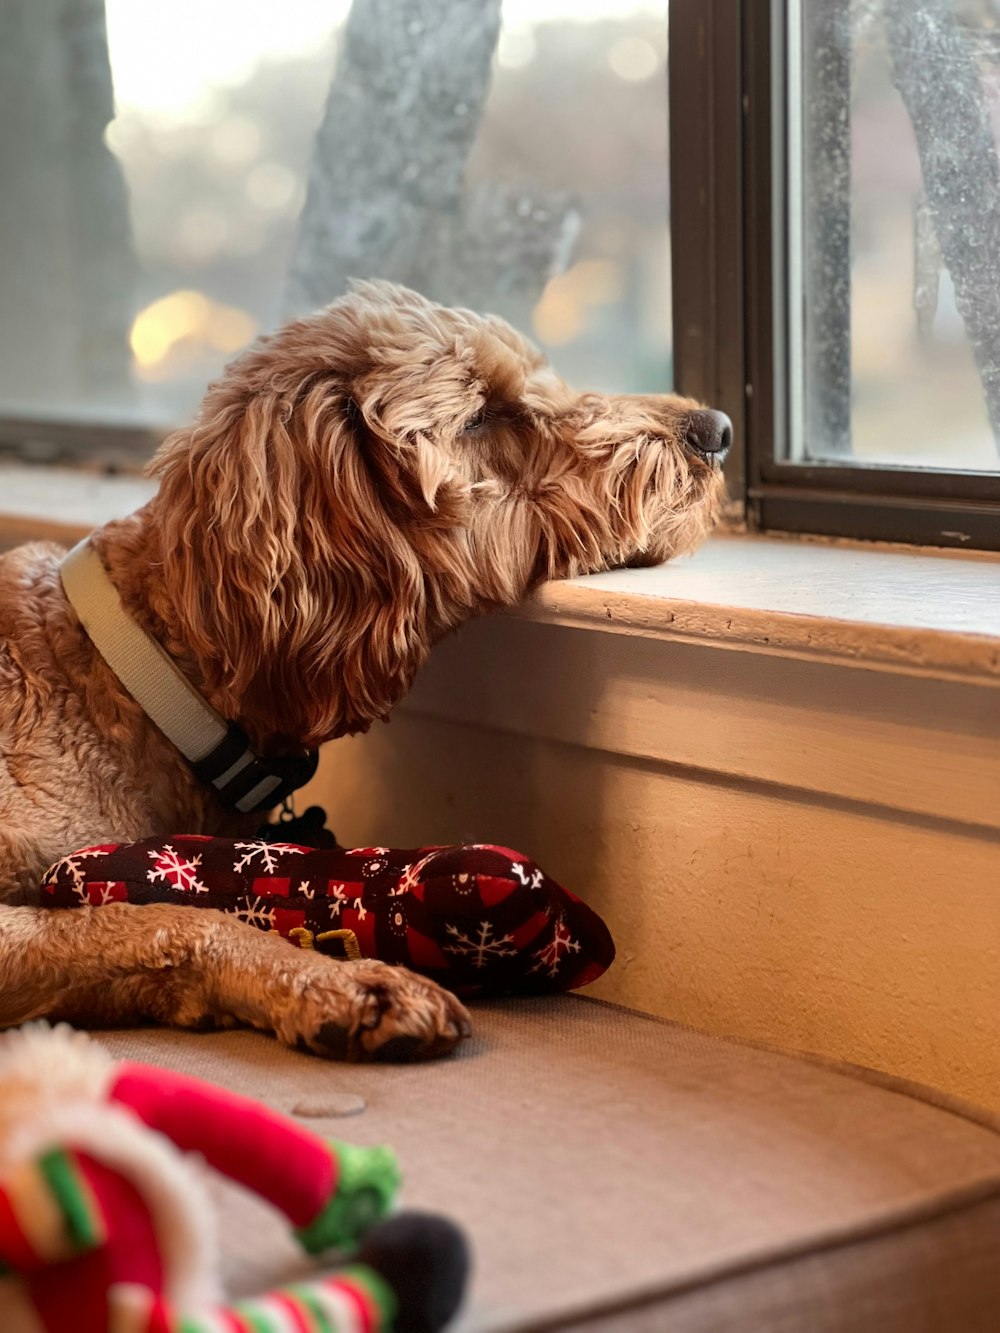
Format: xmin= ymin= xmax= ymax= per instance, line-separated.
xmin=100 ymin=997 xmax=1000 ymax=1333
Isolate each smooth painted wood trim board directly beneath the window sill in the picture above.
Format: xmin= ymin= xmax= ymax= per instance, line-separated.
xmin=400 ymin=619 xmax=1000 ymax=830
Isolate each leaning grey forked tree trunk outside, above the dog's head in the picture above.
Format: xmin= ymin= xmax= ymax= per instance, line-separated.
xmin=287 ymin=0 xmax=576 ymax=313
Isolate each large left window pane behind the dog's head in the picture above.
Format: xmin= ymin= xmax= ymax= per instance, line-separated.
xmin=0 ymin=0 xmax=672 ymax=464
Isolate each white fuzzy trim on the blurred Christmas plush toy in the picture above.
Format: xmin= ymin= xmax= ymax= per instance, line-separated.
xmin=0 ymin=1028 xmax=220 ymax=1309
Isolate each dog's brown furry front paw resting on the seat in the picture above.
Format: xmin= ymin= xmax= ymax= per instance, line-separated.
xmin=269 ymin=950 xmax=472 ymax=1061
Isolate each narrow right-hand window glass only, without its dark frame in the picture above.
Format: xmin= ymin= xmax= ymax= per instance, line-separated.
xmin=787 ymin=0 xmax=1000 ymax=471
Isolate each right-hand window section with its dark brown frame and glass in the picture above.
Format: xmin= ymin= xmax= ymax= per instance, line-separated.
xmin=743 ymin=0 xmax=1000 ymax=549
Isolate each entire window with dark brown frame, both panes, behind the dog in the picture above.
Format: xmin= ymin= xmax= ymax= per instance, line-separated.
xmin=0 ymin=0 xmax=1000 ymax=549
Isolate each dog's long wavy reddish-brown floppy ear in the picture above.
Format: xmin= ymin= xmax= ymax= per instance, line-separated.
xmin=151 ymin=377 xmax=428 ymax=744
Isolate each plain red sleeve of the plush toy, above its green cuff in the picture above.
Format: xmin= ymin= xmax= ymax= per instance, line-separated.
xmin=109 ymin=1064 xmax=337 ymax=1228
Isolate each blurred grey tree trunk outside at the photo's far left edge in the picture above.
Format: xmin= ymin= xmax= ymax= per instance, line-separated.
xmin=0 ymin=0 xmax=135 ymax=408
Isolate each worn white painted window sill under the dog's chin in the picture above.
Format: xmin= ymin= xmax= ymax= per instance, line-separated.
xmin=0 ymin=463 xmax=1000 ymax=685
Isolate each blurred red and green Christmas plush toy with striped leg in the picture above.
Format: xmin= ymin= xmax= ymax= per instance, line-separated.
xmin=0 ymin=1026 xmax=467 ymax=1333
